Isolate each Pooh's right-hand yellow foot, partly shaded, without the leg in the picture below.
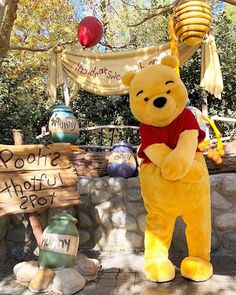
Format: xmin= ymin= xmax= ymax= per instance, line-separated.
xmin=180 ymin=257 xmax=213 ymax=282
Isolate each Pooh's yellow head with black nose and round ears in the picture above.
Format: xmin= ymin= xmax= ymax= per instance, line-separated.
xmin=122 ymin=56 xmax=188 ymax=127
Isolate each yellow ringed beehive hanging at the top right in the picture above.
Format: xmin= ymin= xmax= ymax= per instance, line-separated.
xmin=173 ymin=0 xmax=211 ymax=46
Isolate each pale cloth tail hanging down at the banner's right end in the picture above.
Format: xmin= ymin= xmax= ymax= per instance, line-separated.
xmin=200 ymin=33 xmax=223 ymax=99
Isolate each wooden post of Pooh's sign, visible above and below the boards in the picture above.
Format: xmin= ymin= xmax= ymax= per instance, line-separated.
xmin=12 ymin=129 xmax=42 ymax=246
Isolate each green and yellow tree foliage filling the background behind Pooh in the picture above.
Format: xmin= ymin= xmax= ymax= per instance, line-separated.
xmin=0 ymin=0 xmax=236 ymax=144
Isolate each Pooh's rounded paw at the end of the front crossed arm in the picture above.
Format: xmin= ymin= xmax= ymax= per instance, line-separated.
xmin=161 ymin=150 xmax=193 ymax=180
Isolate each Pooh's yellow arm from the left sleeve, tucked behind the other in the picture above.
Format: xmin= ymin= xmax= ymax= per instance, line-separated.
xmin=144 ymin=143 xmax=172 ymax=168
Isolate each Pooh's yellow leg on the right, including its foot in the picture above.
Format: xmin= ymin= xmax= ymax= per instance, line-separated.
xmin=180 ymin=201 xmax=213 ymax=282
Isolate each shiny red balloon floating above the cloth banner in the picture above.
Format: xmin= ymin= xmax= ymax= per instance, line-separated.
xmin=78 ymin=16 xmax=103 ymax=48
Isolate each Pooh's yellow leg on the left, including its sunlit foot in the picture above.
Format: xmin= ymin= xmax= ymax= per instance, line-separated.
xmin=144 ymin=213 xmax=175 ymax=282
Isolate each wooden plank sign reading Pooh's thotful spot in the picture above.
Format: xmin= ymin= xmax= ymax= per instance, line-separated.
xmin=0 ymin=143 xmax=79 ymax=216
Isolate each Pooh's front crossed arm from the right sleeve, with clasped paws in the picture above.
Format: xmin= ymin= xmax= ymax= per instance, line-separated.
xmin=161 ymin=130 xmax=204 ymax=182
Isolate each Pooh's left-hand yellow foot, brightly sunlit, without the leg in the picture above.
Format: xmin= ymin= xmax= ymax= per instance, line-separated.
xmin=144 ymin=258 xmax=175 ymax=283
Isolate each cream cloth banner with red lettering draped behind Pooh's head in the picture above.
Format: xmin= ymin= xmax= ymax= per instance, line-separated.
xmin=48 ymin=43 xmax=199 ymax=100
